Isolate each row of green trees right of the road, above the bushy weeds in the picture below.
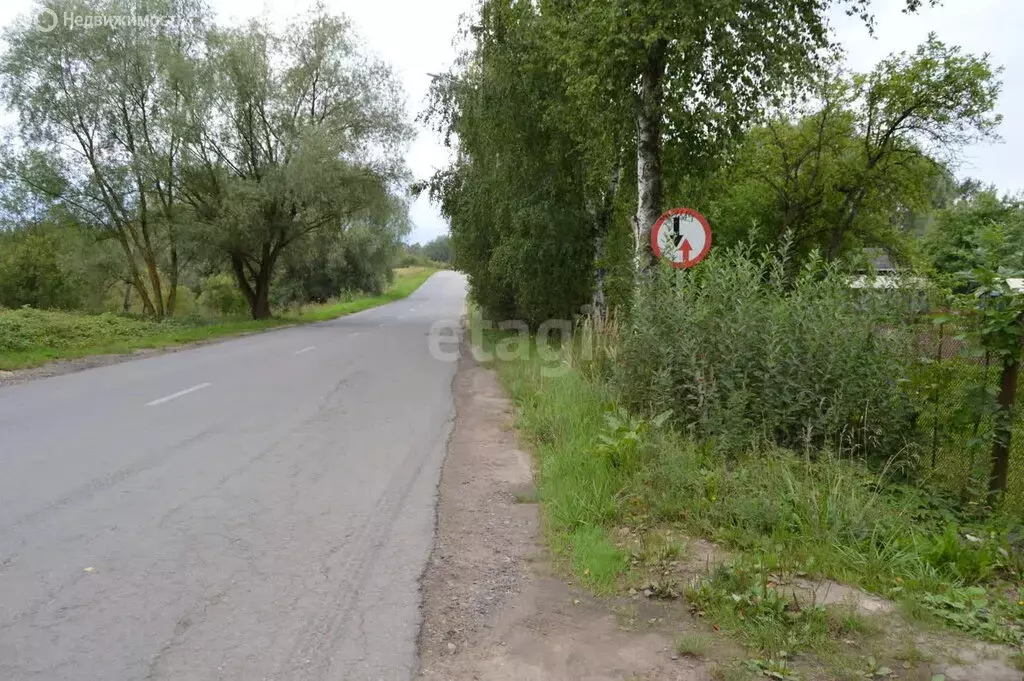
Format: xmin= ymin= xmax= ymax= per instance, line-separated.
xmin=428 ymin=0 xmax=1000 ymax=319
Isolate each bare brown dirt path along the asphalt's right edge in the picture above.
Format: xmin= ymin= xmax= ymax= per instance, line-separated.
xmin=420 ymin=347 xmax=712 ymax=681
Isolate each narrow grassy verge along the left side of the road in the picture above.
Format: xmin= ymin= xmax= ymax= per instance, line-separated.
xmin=0 ymin=267 xmax=436 ymax=371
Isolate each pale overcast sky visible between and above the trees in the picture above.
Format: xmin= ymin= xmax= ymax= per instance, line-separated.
xmin=0 ymin=0 xmax=1024 ymax=243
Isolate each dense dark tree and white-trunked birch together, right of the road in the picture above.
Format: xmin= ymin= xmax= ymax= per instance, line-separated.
xmin=432 ymin=0 xmax=950 ymax=320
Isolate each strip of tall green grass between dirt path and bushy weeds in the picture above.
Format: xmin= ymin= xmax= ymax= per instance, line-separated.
xmin=497 ymin=333 xmax=1024 ymax=642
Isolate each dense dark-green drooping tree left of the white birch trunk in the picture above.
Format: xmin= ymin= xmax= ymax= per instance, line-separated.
xmin=432 ymin=0 xmax=595 ymax=325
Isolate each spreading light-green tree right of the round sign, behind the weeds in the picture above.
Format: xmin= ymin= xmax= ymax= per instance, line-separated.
xmin=683 ymin=36 xmax=999 ymax=266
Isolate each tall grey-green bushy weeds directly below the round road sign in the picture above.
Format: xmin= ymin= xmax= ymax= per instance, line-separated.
xmin=616 ymin=241 xmax=915 ymax=457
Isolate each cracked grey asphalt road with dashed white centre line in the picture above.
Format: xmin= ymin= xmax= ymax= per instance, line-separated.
xmin=0 ymin=272 xmax=465 ymax=681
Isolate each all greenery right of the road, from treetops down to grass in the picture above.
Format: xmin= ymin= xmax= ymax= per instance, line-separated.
xmin=442 ymin=0 xmax=1024 ymax=678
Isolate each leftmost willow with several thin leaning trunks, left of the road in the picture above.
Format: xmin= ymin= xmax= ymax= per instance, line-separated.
xmin=0 ymin=0 xmax=208 ymax=316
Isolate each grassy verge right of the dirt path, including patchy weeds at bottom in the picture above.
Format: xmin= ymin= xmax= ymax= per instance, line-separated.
xmin=484 ymin=313 xmax=1024 ymax=678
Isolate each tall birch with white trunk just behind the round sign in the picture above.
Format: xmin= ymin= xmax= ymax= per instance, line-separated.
xmin=545 ymin=0 xmax=935 ymax=261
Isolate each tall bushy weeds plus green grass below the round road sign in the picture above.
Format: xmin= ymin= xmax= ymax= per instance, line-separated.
xmin=475 ymin=248 xmax=1024 ymax=666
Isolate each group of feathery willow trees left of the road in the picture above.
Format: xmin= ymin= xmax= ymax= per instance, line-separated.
xmin=0 ymin=0 xmax=415 ymax=318
